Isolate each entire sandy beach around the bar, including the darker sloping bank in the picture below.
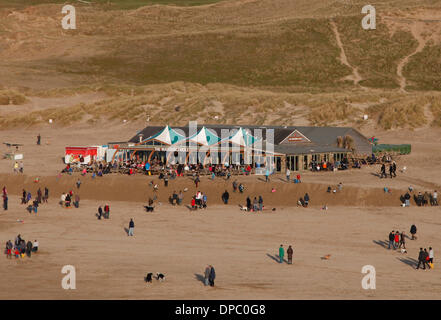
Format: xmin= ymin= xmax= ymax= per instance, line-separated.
xmin=0 ymin=124 xmax=441 ymax=299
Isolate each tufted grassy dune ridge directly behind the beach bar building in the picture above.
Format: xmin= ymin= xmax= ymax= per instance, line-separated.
xmin=0 ymin=82 xmax=441 ymax=129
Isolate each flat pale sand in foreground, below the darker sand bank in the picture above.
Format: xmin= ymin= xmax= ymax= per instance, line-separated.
xmin=0 ymin=197 xmax=441 ymax=299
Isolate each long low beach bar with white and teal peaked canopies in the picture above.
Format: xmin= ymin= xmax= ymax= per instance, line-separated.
xmin=108 ymin=124 xmax=372 ymax=172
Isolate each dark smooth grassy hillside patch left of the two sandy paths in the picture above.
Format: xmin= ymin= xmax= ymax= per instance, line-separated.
xmin=48 ymin=19 xmax=350 ymax=88
